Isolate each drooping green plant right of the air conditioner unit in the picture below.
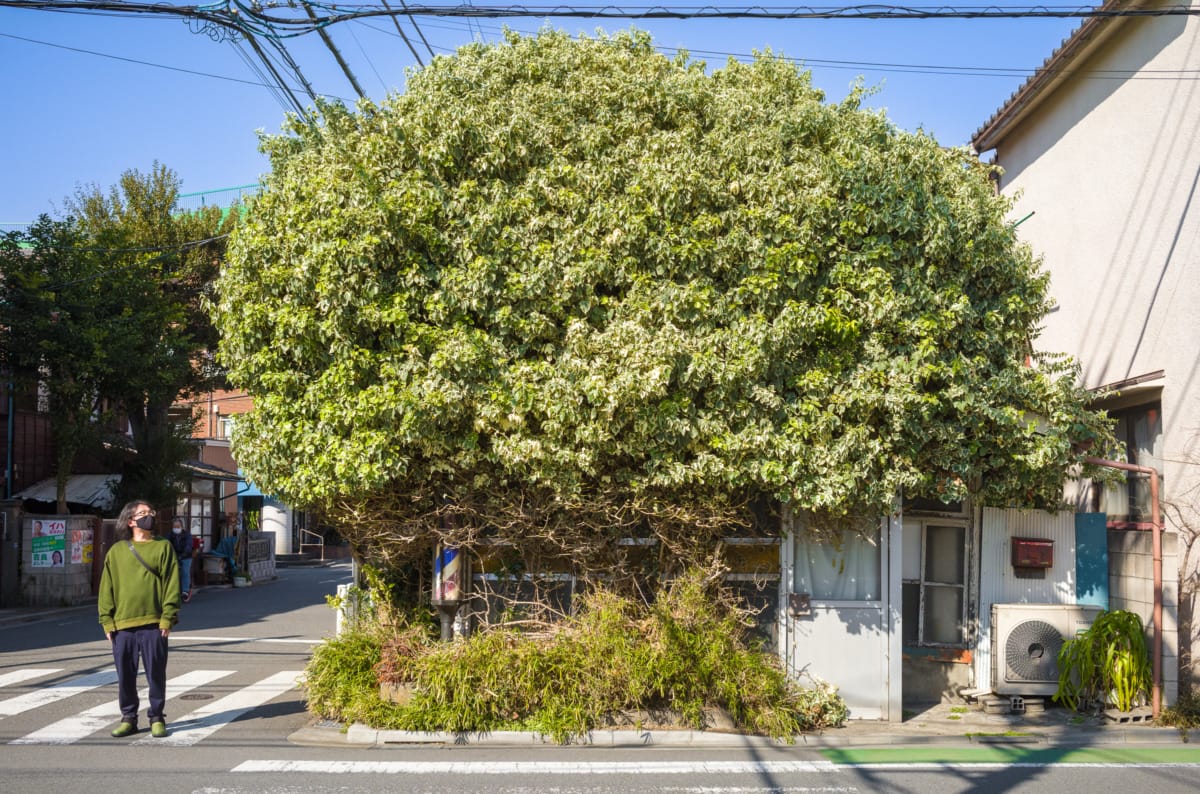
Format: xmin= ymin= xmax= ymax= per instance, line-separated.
xmin=1055 ymin=609 xmax=1152 ymax=711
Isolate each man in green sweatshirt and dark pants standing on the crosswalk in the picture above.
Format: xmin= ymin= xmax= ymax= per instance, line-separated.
xmin=98 ymin=500 xmax=180 ymax=739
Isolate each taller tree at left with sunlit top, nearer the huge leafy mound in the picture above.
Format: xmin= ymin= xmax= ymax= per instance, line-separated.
xmin=67 ymin=163 xmax=236 ymax=504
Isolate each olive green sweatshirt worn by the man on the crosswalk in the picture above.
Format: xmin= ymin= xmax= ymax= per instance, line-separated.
xmin=97 ymin=537 xmax=180 ymax=631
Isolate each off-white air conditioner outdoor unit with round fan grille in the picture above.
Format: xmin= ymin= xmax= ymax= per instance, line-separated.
xmin=991 ymin=603 xmax=1100 ymax=694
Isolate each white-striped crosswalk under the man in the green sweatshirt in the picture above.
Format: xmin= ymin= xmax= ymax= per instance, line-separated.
xmin=0 ymin=668 xmax=304 ymax=747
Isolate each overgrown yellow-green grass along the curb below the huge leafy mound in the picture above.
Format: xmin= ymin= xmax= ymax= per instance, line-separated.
xmin=306 ymin=575 xmax=847 ymax=742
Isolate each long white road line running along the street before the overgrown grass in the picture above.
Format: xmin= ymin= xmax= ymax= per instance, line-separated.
xmin=230 ymin=760 xmax=846 ymax=775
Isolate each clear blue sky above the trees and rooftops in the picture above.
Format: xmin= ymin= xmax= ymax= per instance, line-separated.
xmin=0 ymin=2 xmax=1079 ymax=229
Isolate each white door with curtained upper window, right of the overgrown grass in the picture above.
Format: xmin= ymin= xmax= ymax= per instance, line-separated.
xmin=780 ymin=516 xmax=901 ymax=720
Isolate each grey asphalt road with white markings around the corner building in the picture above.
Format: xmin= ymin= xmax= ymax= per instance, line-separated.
xmin=0 ymin=565 xmax=1200 ymax=794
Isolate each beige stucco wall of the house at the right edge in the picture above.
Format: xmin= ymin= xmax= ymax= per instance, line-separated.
xmin=996 ymin=18 xmax=1200 ymax=695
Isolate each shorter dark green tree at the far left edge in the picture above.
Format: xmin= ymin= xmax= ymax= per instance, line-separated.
xmin=0 ymin=215 xmax=136 ymax=513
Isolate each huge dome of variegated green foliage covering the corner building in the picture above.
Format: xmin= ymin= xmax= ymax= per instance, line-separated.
xmin=215 ymin=31 xmax=1111 ymax=578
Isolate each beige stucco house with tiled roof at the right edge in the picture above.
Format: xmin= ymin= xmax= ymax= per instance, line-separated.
xmin=972 ymin=2 xmax=1200 ymax=702
